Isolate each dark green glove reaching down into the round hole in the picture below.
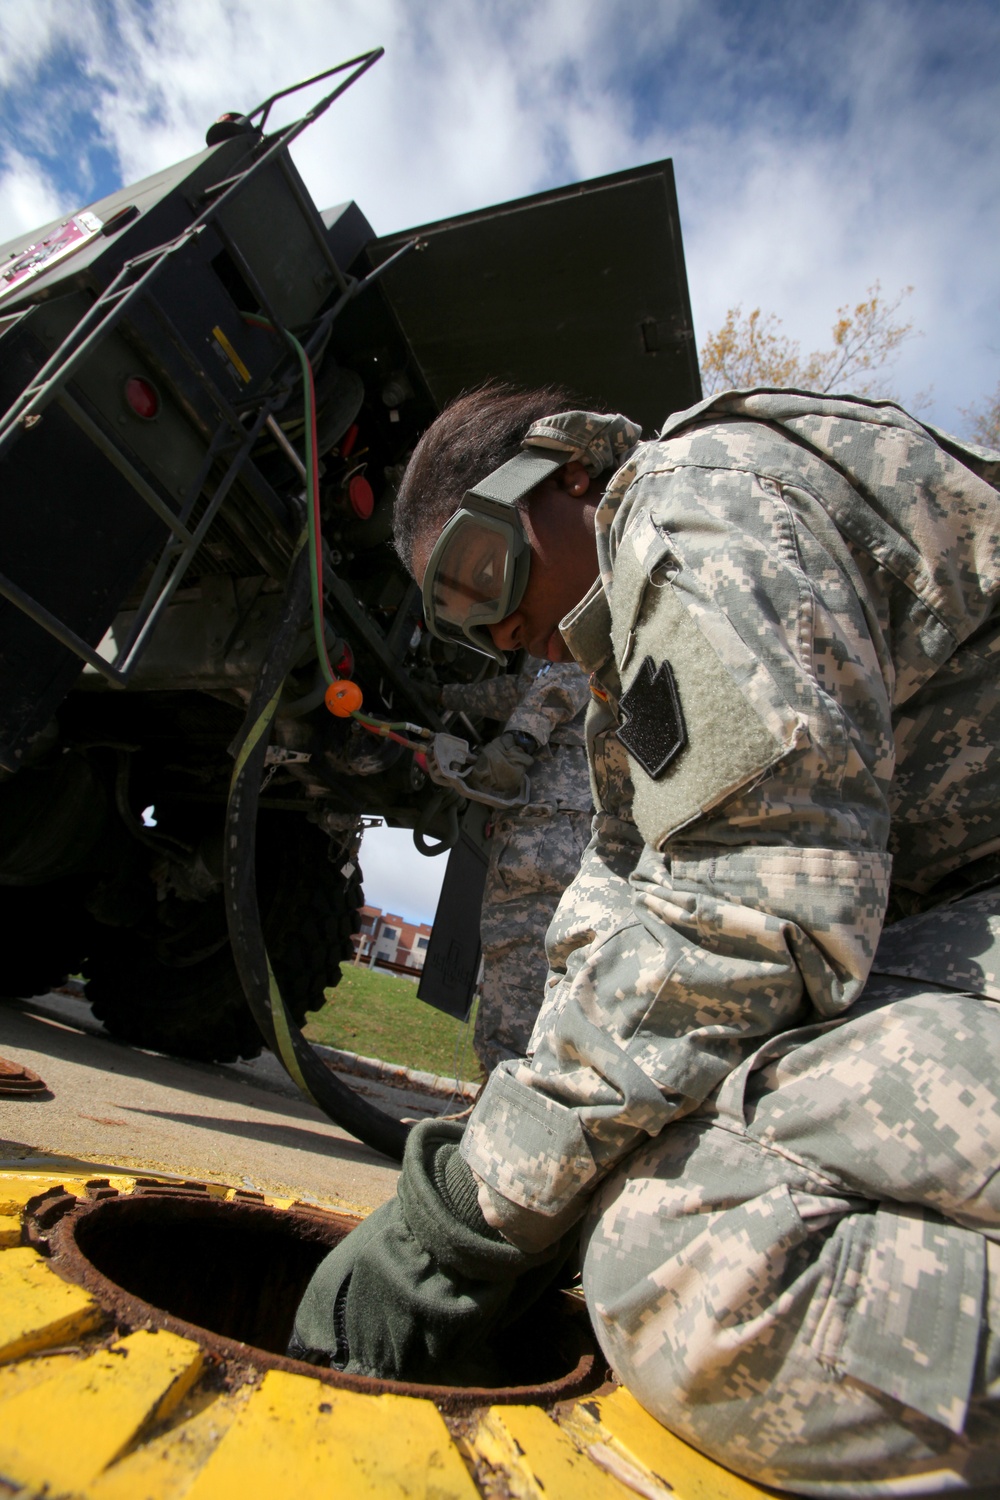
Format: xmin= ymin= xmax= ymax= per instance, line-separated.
xmin=288 ymin=1119 xmax=577 ymax=1385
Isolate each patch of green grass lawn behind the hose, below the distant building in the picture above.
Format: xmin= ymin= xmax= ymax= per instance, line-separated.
xmin=304 ymin=963 xmax=480 ymax=1079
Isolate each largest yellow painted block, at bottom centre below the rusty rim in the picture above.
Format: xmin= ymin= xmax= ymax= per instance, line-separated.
xmin=186 ymin=1370 xmax=477 ymax=1500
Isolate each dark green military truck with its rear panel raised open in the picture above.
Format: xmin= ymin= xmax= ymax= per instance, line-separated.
xmin=0 ymin=53 xmax=699 ymax=1146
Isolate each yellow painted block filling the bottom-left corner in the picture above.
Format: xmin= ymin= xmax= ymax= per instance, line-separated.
xmin=0 ymin=1332 xmax=201 ymax=1493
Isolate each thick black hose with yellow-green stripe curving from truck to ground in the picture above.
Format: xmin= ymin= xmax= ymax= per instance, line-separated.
xmin=223 ymin=548 xmax=409 ymax=1161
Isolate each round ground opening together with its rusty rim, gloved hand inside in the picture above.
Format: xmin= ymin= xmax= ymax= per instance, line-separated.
xmin=33 ymin=1181 xmax=607 ymax=1413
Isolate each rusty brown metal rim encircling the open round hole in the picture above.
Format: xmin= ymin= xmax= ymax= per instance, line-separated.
xmin=39 ymin=1184 xmax=606 ymax=1415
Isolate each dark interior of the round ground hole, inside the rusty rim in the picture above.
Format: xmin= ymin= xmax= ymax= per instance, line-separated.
xmin=54 ymin=1191 xmax=595 ymax=1400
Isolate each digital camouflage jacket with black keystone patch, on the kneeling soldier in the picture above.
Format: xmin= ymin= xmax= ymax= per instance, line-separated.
xmin=462 ymin=392 xmax=1000 ymax=1248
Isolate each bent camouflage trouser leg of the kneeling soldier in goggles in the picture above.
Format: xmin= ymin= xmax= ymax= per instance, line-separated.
xmin=583 ymin=978 xmax=1000 ymax=1496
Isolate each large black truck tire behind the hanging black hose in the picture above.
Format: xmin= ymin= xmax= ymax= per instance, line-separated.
xmin=85 ymin=816 xmax=363 ymax=1062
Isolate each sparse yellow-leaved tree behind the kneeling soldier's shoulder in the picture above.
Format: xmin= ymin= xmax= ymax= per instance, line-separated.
xmin=700 ymin=282 xmax=913 ymax=396
